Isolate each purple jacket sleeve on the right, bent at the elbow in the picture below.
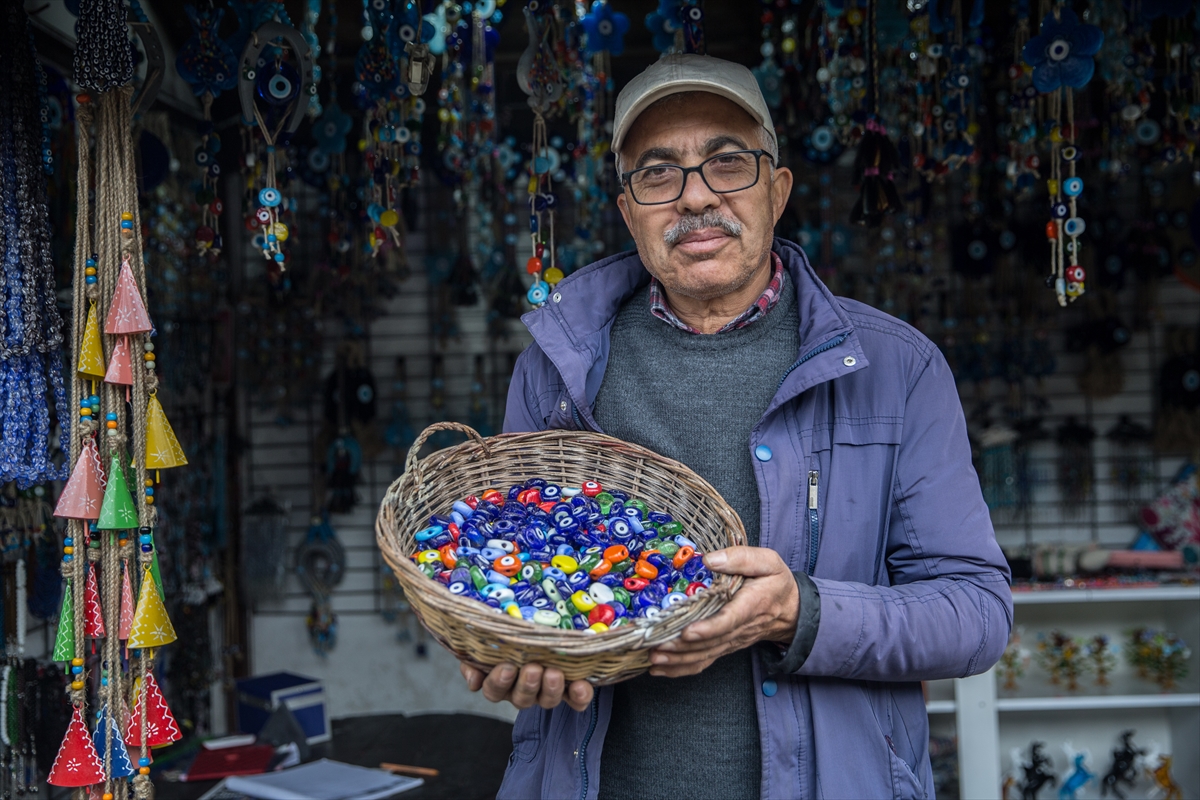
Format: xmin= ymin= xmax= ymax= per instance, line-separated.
xmin=797 ymin=350 xmax=1013 ymax=681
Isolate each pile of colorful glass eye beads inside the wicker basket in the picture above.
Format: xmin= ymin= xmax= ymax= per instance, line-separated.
xmin=412 ymin=479 xmax=713 ymax=633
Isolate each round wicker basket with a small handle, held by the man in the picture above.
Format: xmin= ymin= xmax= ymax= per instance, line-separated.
xmin=376 ymin=422 xmax=746 ymax=685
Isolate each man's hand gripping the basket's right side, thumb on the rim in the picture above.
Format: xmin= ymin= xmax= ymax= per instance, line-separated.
xmin=650 ymin=547 xmax=800 ymax=678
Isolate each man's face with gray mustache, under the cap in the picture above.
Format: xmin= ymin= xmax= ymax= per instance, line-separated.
xmin=617 ymin=92 xmax=792 ymax=300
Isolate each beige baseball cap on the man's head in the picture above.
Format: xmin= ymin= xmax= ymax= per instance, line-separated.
xmin=612 ymin=53 xmax=779 ymax=160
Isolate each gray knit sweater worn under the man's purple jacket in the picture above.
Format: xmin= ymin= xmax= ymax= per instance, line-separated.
xmin=594 ymin=272 xmax=799 ymax=800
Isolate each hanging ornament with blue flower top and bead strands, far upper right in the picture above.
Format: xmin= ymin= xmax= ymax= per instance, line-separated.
xmin=1022 ymin=6 xmax=1104 ymax=306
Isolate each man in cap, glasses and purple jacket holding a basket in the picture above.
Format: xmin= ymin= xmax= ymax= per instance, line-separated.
xmin=463 ymin=55 xmax=1012 ymax=799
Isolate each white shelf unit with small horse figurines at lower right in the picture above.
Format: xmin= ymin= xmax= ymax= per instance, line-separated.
xmin=945 ymin=585 xmax=1200 ymax=800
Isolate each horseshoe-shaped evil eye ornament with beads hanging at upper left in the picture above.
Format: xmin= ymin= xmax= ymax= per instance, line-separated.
xmin=238 ymin=20 xmax=317 ymax=276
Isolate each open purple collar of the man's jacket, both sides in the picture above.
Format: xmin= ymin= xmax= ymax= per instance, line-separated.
xmin=521 ymin=239 xmax=868 ymax=428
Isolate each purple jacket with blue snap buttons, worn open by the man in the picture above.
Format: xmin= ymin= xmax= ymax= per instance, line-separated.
xmin=498 ymin=240 xmax=1013 ymax=800
